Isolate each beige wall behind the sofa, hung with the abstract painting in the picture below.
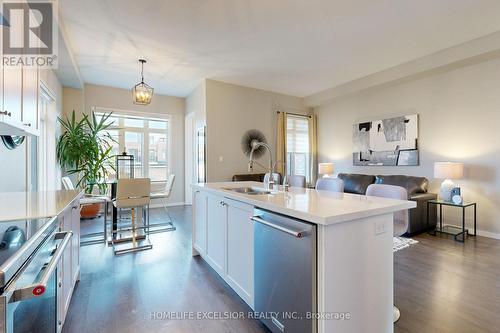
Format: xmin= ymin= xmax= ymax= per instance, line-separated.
xmin=314 ymin=59 xmax=500 ymax=237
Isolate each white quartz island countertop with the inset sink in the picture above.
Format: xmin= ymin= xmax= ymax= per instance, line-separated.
xmin=192 ymin=182 xmax=416 ymax=225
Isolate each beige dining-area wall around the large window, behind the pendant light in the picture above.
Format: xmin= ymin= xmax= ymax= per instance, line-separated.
xmin=84 ymin=84 xmax=185 ymax=204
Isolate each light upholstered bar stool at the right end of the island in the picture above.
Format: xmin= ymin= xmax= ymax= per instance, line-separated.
xmin=366 ymin=184 xmax=408 ymax=322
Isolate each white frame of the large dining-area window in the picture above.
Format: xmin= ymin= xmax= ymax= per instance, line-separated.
xmin=91 ymin=107 xmax=172 ymax=182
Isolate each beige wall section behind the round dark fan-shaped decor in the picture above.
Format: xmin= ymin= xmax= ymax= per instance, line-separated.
xmin=206 ymin=80 xmax=310 ymax=182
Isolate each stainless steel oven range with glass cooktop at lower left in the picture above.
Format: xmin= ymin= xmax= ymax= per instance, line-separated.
xmin=0 ymin=217 xmax=72 ymax=333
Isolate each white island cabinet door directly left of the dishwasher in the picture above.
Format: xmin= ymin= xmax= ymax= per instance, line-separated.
xmin=224 ymin=199 xmax=253 ymax=308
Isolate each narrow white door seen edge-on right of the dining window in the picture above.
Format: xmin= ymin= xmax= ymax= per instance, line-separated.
xmin=184 ymin=112 xmax=195 ymax=205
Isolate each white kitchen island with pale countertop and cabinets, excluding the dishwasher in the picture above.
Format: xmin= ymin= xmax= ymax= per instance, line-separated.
xmin=193 ymin=182 xmax=415 ymax=333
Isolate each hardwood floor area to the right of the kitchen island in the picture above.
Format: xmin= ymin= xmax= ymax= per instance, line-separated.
xmin=394 ymin=234 xmax=500 ymax=333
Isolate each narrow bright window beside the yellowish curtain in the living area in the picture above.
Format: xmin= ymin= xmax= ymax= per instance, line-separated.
xmin=286 ymin=114 xmax=311 ymax=183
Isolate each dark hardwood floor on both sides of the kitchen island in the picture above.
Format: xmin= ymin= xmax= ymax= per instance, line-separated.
xmin=63 ymin=206 xmax=500 ymax=333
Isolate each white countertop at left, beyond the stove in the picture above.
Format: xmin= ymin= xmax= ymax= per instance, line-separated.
xmin=0 ymin=190 xmax=83 ymax=222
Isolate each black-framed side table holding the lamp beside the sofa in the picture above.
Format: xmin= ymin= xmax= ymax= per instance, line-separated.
xmin=427 ymin=200 xmax=477 ymax=243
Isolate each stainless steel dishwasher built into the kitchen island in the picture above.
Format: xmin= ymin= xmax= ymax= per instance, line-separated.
xmin=252 ymin=209 xmax=317 ymax=333
